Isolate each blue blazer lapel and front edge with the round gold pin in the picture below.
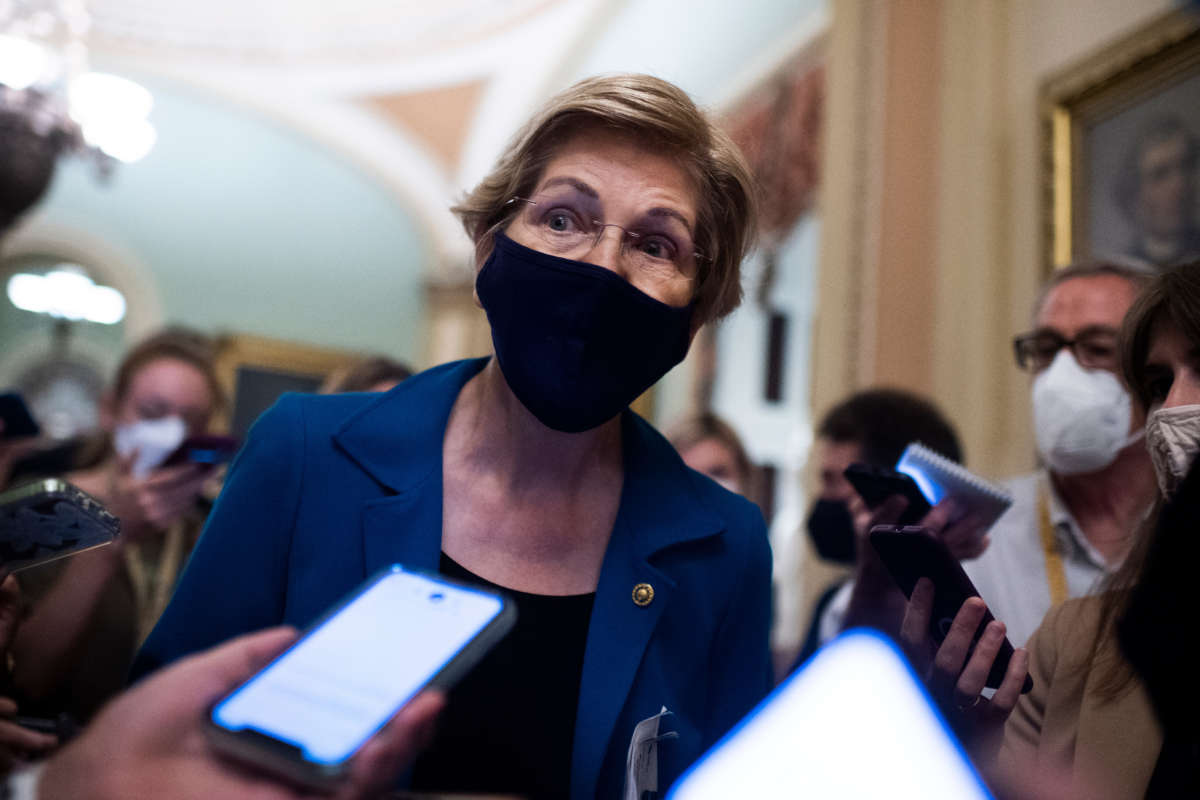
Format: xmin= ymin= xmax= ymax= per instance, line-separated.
xmin=571 ymin=413 xmax=724 ymax=800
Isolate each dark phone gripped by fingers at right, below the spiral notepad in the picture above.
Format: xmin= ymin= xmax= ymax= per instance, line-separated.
xmin=870 ymin=525 xmax=1033 ymax=693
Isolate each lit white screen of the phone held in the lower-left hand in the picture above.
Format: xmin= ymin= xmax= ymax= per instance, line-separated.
xmin=212 ymin=567 xmax=503 ymax=764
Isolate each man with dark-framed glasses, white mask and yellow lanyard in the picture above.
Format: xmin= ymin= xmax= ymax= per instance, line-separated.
xmin=964 ymin=264 xmax=1156 ymax=645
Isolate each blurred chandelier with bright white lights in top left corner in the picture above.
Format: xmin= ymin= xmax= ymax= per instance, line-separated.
xmin=0 ymin=0 xmax=155 ymax=231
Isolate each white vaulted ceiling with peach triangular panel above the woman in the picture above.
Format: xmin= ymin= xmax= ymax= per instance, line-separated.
xmin=82 ymin=0 xmax=828 ymax=271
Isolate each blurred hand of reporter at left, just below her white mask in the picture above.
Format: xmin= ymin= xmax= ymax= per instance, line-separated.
xmin=102 ymin=452 xmax=212 ymax=541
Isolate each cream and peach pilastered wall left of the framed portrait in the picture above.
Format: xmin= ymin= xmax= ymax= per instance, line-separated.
xmin=800 ymin=0 xmax=1172 ymax=662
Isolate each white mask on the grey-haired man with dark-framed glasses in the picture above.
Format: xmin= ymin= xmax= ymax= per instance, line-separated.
xmin=1033 ymin=348 xmax=1142 ymax=475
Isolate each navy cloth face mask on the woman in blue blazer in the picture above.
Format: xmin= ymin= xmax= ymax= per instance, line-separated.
xmin=475 ymin=233 xmax=692 ymax=433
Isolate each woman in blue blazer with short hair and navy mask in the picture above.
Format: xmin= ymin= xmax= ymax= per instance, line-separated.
xmin=134 ymin=76 xmax=770 ymax=800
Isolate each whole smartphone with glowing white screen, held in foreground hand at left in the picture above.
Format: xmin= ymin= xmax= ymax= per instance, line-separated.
xmin=206 ymin=565 xmax=516 ymax=792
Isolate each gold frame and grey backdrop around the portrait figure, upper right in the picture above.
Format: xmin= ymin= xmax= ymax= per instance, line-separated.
xmin=1040 ymin=10 xmax=1200 ymax=269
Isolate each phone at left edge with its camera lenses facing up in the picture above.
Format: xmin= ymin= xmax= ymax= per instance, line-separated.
xmin=0 ymin=477 xmax=121 ymax=572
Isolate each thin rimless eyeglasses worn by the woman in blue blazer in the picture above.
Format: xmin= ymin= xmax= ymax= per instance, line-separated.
xmin=505 ymin=193 xmax=709 ymax=281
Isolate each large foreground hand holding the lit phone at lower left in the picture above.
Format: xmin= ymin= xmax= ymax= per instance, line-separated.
xmin=38 ymin=628 xmax=444 ymax=800
